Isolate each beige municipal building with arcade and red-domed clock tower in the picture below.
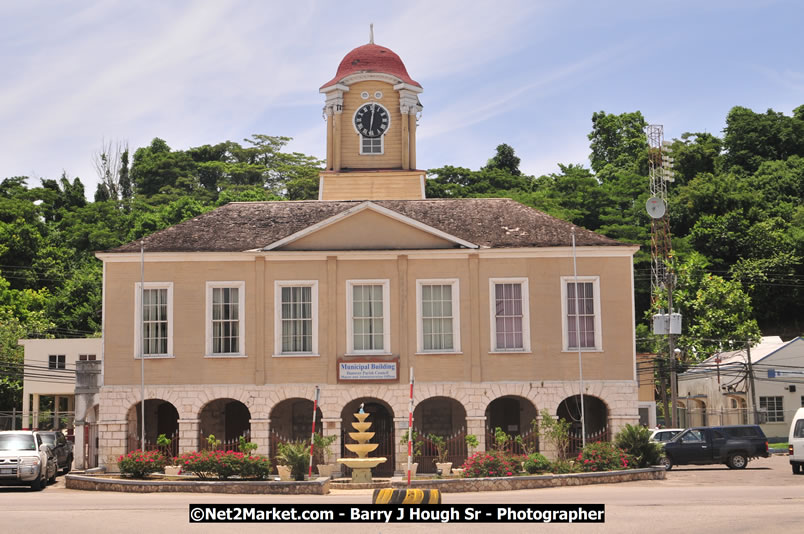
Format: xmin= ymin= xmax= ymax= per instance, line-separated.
xmin=92 ymin=38 xmax=639 ymax=474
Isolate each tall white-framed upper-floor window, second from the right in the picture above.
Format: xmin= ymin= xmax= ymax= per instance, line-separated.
xmin=489 ymin=278 xmax=530 ymax=352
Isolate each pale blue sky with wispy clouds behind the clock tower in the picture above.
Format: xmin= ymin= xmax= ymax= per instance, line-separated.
xmin=0 ymin=0 xmax=804 ymax=198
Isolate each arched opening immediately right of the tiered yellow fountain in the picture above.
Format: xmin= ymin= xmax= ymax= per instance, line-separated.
xmin=413 ymin=397 xmax=467 ymax=473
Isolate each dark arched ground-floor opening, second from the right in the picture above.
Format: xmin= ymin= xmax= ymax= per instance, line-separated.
xmin=486 ymin=395 xmax=539 ymax=454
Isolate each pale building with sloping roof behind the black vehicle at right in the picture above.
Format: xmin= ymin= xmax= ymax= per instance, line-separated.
xmin=678 ymin=336 xmax=804 ymax=438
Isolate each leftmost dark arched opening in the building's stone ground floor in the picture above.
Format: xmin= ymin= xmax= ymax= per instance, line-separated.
xmin=127 ymin=399 xmax=179 ymax=456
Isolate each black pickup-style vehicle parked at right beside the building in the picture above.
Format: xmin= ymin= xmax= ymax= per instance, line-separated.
xmin=663 ymin=425 xmax=769 ymax=470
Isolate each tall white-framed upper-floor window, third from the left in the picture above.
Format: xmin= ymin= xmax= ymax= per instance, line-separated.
xmin=274 ymin=280 xmax=318 ymax=356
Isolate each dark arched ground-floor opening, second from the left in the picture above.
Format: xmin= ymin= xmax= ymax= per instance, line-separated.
xmin=198 ymin=399 xmax=251 ymax=450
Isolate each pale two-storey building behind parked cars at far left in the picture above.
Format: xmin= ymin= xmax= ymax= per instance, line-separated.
xmin=18 ymin=338 xmax=103 ymax=429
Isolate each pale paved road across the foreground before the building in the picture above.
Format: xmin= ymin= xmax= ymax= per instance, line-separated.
xmin=0 ymin=456 xmax=804 ymax=534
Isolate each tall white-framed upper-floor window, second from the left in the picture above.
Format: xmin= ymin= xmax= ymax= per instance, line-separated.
xmin=206 ymin=281 xmax=246 ymax=357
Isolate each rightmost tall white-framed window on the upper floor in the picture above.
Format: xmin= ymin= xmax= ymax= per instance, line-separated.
xmin=561 ymin=276 xmax=603 ymax=352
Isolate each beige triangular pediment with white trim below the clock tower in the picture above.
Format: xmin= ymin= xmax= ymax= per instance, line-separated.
xmin=263 ymin=202 xmax=478 ymax=250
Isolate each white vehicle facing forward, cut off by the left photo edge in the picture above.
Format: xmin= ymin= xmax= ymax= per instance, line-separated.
xmin=0 ymin=430 xmax=57 ymax=491
